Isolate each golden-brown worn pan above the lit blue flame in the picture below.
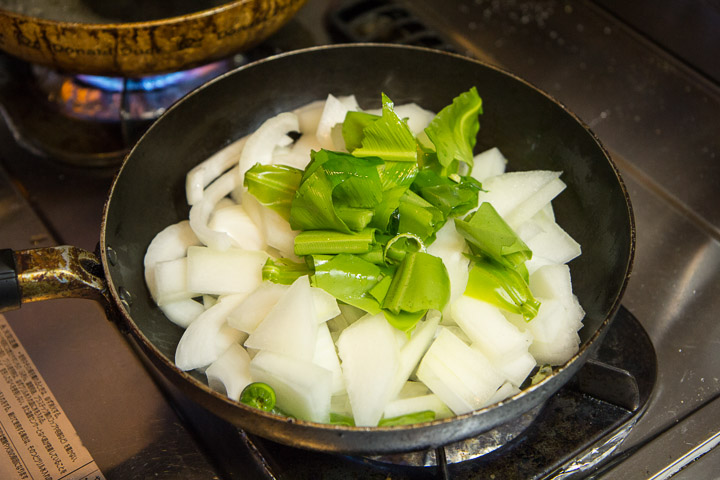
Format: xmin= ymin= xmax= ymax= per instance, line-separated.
xmin=0 ymin=0 xmax=306 ymax=77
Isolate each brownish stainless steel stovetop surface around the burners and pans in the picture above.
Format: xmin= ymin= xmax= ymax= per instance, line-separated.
xmin=0 ymin=0 xmax=720 ymax=478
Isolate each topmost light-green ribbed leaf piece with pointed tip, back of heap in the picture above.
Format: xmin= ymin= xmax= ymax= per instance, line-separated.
xmin=346 ymin=93 xmax=417 ymax=163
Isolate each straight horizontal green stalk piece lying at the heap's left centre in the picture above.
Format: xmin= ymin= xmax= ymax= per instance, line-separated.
xmin=295 ymin=228 xmax=375 ymax=255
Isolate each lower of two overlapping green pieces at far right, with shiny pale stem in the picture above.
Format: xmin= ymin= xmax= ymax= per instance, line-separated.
xmin=465 ymin=258 xmax=540 ymax=322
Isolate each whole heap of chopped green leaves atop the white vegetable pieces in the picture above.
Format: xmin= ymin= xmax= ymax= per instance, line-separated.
xmin=245 ymin=88 xmax=537 ymax=331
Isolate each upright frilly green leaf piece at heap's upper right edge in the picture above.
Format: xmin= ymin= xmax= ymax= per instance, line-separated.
xmin=425 ymin=87 xmax=482 ymax=173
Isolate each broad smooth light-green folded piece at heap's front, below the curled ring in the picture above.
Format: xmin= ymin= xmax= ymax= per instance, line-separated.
xmin=383 ymin=252 xmax=450 ymax=314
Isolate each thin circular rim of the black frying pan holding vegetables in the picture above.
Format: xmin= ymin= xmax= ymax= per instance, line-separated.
xmin=100 ymin=43 xmax=636 ymax=432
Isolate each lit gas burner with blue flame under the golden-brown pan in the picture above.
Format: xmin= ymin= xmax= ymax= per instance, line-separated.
xmin=0 ymin=54 xmax=247 ymax=170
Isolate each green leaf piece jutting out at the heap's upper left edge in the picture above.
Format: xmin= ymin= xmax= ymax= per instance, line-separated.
xmin=244 ymin=163 xmax=303 ymax=220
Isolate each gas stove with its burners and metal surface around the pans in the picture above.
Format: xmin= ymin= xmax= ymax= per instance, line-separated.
xmin=0 ymin=0 xmax=720 ymax=479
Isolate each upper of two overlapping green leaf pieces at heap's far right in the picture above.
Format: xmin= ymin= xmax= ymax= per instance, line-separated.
xmin=455 ymin=202 xmax=532 ymax=268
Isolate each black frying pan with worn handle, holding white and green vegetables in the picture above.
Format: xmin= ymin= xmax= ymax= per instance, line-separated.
xmin=0 ymin=45 xmax=635 ymax=453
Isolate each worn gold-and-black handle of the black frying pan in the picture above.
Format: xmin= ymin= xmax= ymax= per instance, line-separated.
xmin=0 ymin=246 xmax=111 ymax=312
